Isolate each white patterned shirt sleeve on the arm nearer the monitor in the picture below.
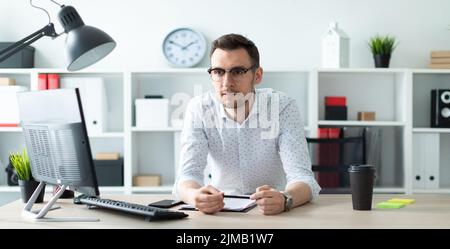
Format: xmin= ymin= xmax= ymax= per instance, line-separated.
xmin=172 ymin=100 xmax=209 ymax=198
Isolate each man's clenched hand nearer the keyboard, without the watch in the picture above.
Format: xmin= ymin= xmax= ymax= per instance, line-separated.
xmin=193 ymin=185 xmax=225 ymax=214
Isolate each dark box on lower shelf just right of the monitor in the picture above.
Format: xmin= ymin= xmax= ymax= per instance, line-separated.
xmin=94 ymin=158 xmax=123 ymax=186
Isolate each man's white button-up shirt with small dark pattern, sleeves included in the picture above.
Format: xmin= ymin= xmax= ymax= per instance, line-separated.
xmin=173 ymin=88 xmax=321 ymax=199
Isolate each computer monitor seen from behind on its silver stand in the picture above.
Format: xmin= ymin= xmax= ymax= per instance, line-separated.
xmin=17 ymin=89 xmax=100 ymax=221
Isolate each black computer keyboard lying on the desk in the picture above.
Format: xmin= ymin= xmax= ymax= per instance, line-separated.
xmin=74 ymin=195 xmax=188 ymax=221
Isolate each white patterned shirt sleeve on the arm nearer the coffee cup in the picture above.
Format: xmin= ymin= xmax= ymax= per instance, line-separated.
xmin=278 ymin=99 xmax=321 ymax=200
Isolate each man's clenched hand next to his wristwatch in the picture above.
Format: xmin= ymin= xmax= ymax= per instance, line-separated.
xmin=250 ymin=185 xmax=284 ymax=215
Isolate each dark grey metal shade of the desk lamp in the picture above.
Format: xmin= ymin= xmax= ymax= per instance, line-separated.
xmin=66 ymin=25 xmax=116 ymax=71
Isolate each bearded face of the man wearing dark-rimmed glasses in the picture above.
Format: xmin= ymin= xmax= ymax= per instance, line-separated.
xmin=211 ymin=48 xmax=262 ymax=108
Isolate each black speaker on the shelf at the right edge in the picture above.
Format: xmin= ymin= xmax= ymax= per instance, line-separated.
xmin=430 ymin=89 xmax=450 ymax=128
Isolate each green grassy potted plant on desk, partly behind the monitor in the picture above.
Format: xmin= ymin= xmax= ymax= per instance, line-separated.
xmin=9 ymin=149 xmax=45 ymax=203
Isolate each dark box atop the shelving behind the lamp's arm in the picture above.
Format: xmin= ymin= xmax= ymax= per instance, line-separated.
xmin=0 ymin=42 xmax=35 ymax=68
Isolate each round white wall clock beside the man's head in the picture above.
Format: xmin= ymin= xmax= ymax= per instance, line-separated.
xmin=163 ymin=28 xmax=206 ymax=67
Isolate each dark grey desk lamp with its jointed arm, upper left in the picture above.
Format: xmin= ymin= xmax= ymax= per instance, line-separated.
xmin=0 ymin=0 xmax=116 ymax=71
